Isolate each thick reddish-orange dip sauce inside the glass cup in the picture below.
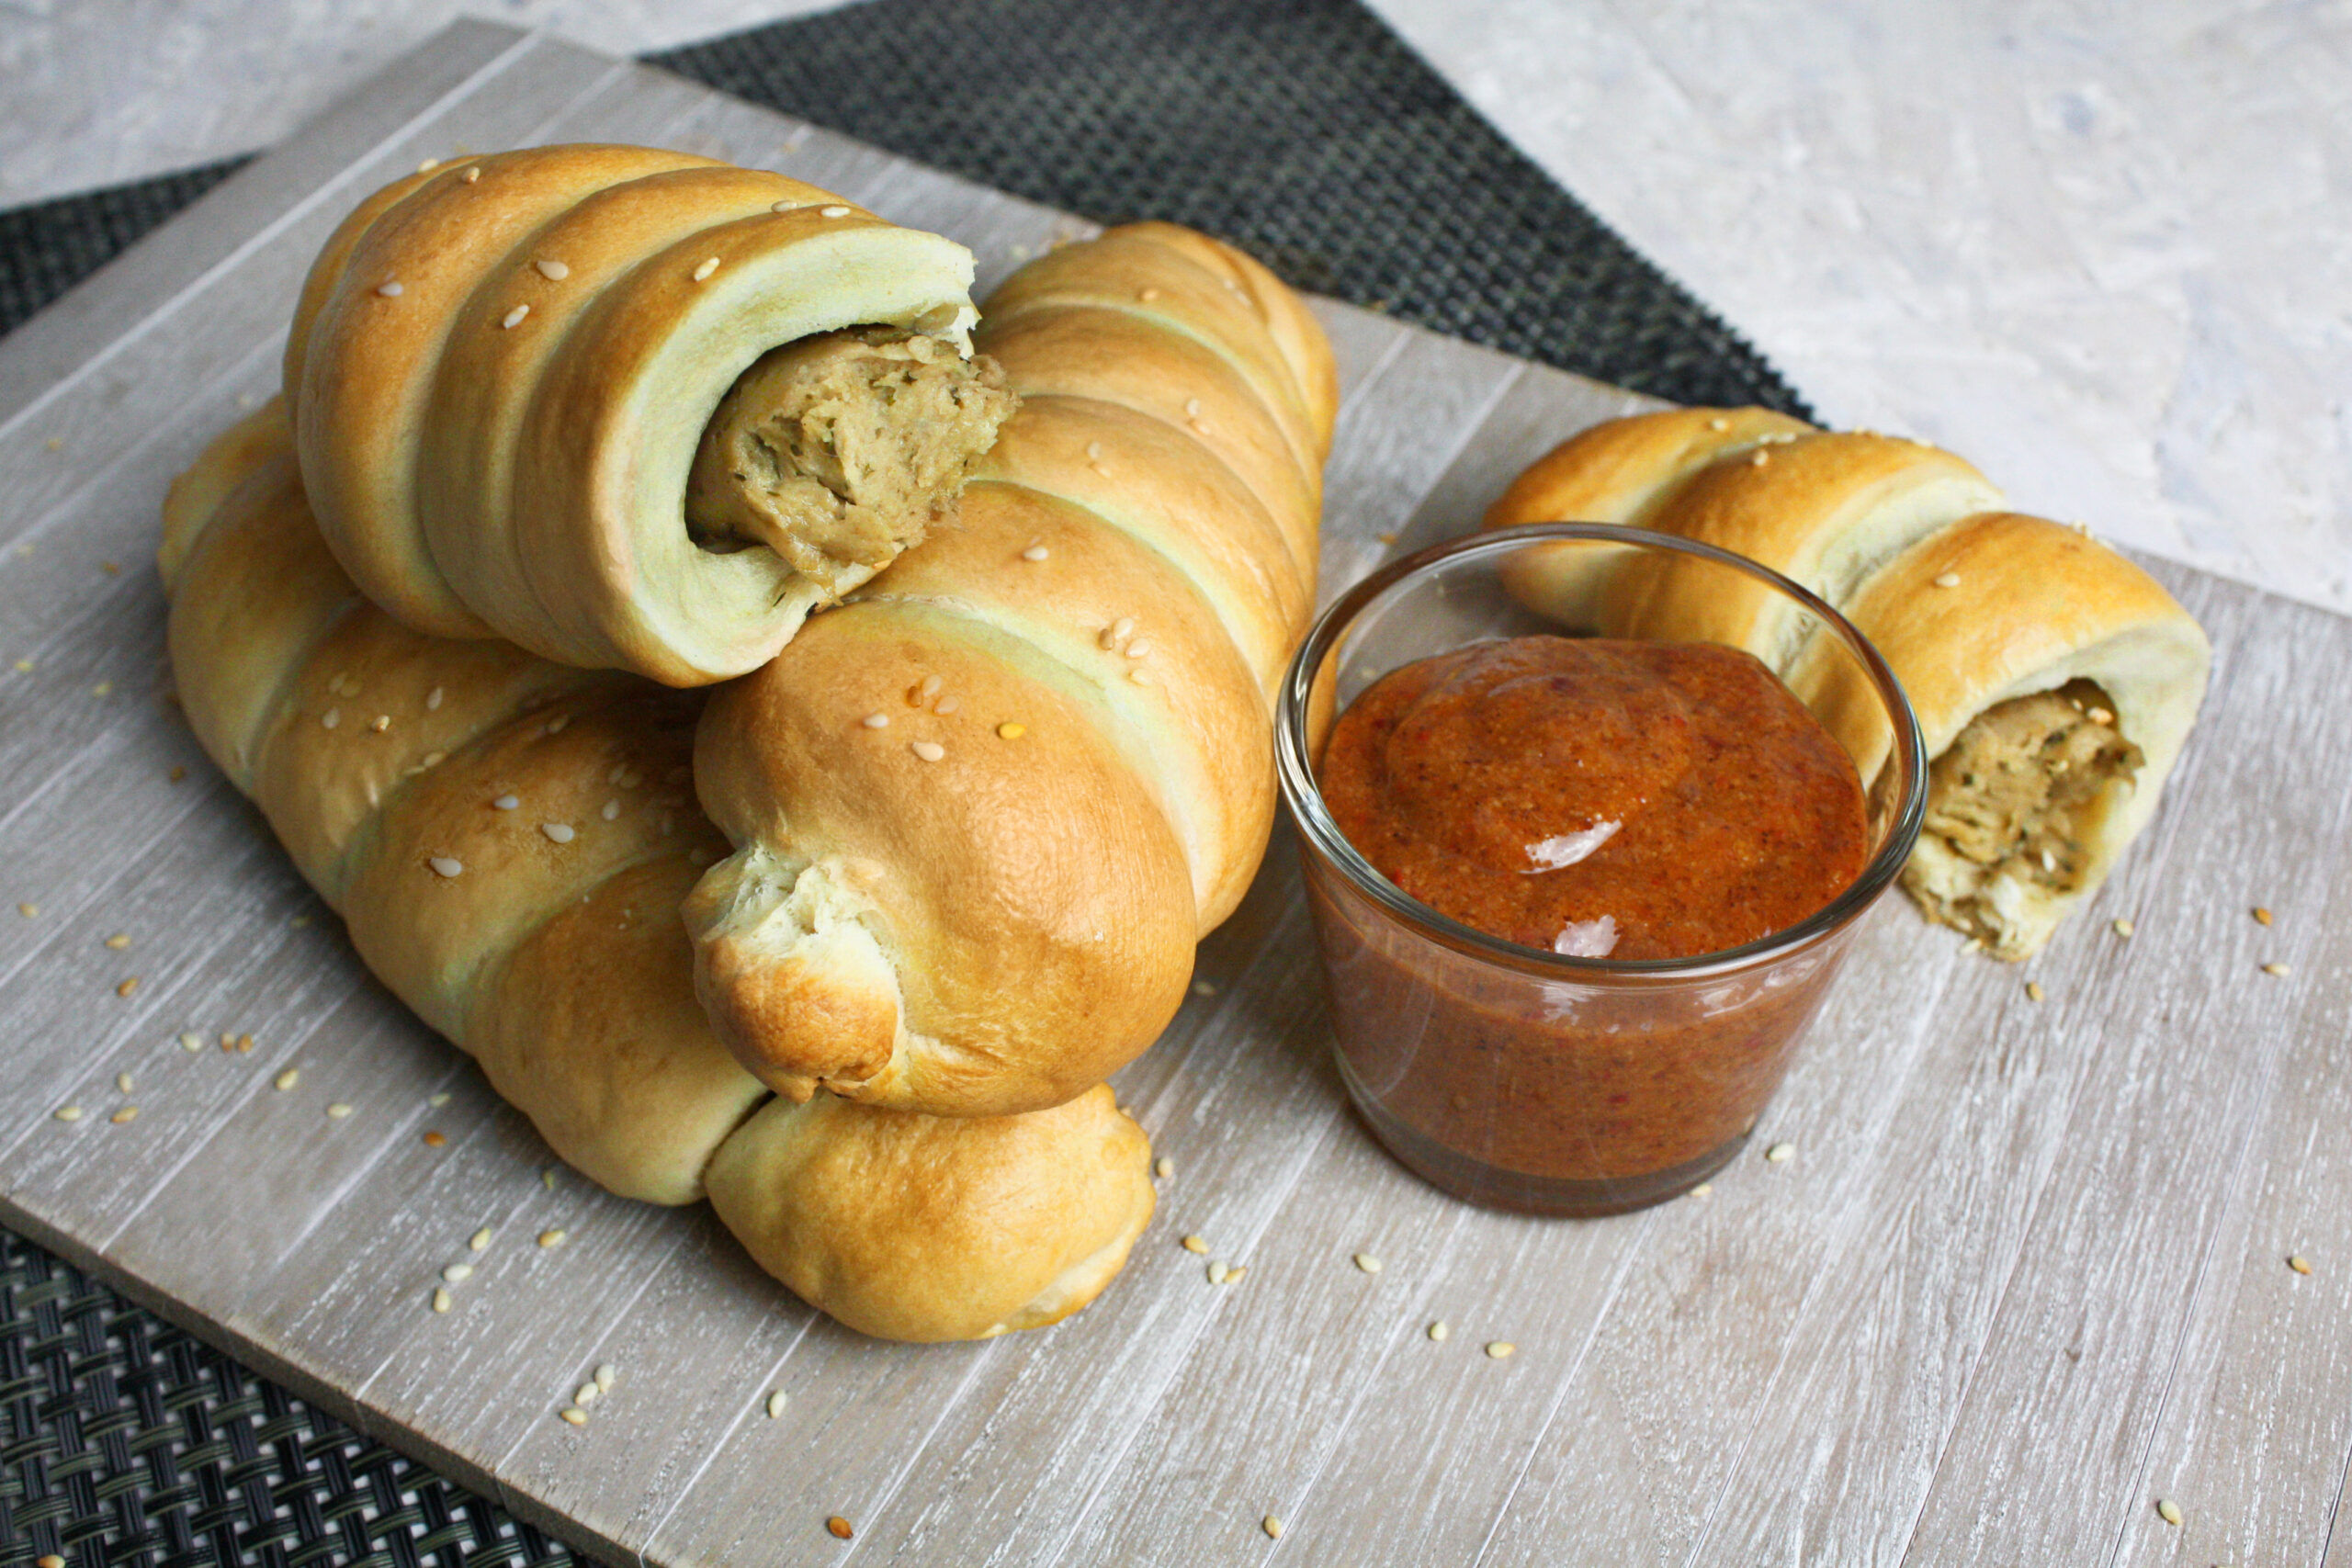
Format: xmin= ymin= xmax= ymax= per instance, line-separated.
xmin=1307 ymin=637 xmax=1870 ymax=1213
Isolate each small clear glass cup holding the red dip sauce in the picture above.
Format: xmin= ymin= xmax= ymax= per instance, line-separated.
xmin=1275 ymin=522 xmax=1927 ymax=1215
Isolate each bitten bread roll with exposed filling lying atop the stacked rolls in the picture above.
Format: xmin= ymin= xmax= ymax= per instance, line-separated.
xmin=285 ymin=146 xmax=1012 ymax=686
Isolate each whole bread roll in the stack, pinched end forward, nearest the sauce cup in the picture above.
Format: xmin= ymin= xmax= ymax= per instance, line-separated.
xmin=687 ymin=223 xmax=1336 ymax=1114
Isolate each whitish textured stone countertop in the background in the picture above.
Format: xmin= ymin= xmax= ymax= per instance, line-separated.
xmin=0 ymin=0 xmax=2352 ymax=611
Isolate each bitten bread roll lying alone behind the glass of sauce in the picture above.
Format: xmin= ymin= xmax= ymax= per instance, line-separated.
xmin=1487 ymin=409 xmax=2211 ymax=959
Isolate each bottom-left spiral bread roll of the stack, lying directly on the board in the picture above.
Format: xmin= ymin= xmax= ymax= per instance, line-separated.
xmin=160 ymin=404 xmax=1152 ymax=1340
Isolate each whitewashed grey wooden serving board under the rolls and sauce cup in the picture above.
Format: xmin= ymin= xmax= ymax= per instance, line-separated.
xmin=0 ymin=24 xmax=2352 ymax=1568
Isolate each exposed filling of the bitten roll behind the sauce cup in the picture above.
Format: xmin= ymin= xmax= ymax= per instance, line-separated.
xmin=1903 ymin=680 xmax=2143 ymax=941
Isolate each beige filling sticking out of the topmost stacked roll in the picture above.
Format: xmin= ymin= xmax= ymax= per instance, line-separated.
xmin=687 ymin=327 xmax=1018 ymax=594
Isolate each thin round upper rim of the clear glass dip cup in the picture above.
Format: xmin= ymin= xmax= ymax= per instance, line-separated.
xmin=1275 ymin=522 xmax=1927 ymax=983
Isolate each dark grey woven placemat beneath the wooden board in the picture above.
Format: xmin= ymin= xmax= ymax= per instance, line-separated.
xmin=0 ymin=0 xmax=1806 ymax=1568
